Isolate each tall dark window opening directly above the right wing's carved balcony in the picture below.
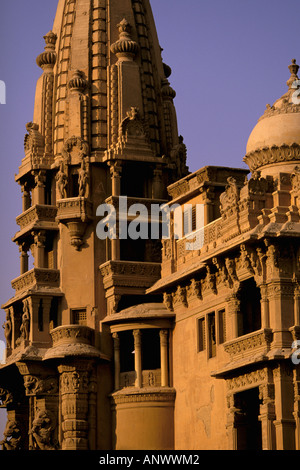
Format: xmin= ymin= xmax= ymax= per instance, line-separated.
xmin=239 ymin=278 xmax=261 ymax=336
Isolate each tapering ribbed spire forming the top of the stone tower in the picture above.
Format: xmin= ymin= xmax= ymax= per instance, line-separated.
xmin=24 ymin=0 xmax=188 ymax=179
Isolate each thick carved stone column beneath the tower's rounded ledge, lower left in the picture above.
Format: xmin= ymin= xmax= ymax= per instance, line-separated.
xmin=58 ymin=359 xmax=91 ymax=450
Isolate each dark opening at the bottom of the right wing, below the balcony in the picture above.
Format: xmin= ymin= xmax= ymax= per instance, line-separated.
xmin=234 ymin=387 xmax=262 ymax=450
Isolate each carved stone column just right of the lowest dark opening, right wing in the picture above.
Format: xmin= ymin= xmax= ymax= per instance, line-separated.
xmin=259 ymin=383 xmax=276 ymax=450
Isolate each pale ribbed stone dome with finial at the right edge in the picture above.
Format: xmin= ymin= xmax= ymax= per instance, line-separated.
xmin=244 ymin=59 xmax=300 ymax=174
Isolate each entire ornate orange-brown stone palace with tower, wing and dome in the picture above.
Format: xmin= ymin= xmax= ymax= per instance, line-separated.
xmin=0 ymin=0 xmax=300 ymax=450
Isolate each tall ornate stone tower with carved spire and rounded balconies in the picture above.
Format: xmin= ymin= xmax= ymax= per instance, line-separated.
xmin=0 ymin=0 xmax=187 ymax=450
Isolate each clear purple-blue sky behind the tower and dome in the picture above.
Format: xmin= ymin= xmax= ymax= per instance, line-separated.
xmin=0 ymin=0 xmax=300 ymax=440
